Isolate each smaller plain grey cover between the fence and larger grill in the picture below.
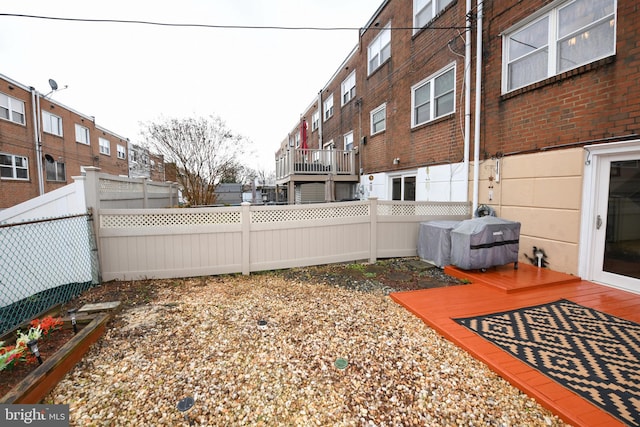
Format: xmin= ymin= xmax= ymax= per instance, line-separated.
xmin=418 ymin=221 xmax=460 ymax=268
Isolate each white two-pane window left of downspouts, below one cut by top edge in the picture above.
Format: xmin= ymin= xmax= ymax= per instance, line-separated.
xmin=411 ymin=63 xmax=456 ymax=127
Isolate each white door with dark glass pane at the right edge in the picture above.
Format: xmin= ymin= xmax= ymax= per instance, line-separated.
xmin=591 ymin=151 xmax=640 ymax=292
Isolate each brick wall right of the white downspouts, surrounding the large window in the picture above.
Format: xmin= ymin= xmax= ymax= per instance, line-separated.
xmin=482 ymin=0 xmax=640 ymax=157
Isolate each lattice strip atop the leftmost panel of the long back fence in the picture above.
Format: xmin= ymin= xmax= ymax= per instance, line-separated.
xmin=100 ymin=210 xmax=241 ymax=228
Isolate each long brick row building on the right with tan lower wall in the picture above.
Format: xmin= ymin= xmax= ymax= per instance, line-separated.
xmin=276 ymin=0 xmax=640 ymax=291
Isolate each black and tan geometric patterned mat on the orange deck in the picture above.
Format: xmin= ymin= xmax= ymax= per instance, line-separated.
xmin=453 ymin=299 xmax=640 ymax=426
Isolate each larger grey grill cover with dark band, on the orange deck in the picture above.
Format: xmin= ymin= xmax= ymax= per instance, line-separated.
xmin=451 ymin=216 xmax=520 ymax=270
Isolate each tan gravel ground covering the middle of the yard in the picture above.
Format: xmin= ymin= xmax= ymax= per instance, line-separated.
xmin=45 ymin=270 xmax=565 ymax=426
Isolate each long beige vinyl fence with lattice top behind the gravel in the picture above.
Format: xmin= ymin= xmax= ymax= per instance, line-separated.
xmin=96 ymin=199 xmax=471 ymax=281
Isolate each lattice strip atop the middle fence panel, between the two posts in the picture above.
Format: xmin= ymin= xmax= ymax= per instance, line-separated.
xmin=251 ymin=204 xmax=369 ymax=224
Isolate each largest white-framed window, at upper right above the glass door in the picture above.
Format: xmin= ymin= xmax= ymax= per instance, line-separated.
xmin=502 ymin=0 xmax=616 ymax=92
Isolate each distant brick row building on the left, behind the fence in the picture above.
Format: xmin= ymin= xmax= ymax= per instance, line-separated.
xmin=0 ymin=75 xmax=168 ymax=209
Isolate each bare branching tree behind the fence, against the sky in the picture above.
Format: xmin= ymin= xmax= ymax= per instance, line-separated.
xmin=142 ymin=115 xmax=248 ymax=205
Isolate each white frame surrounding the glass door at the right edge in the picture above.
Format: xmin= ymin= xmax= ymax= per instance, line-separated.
xmin=578 ymin=139 xmax=640 ymax=292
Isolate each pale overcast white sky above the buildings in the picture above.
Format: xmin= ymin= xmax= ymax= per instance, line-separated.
xmin=0 ymin=0 xmax=382 ymax=171
